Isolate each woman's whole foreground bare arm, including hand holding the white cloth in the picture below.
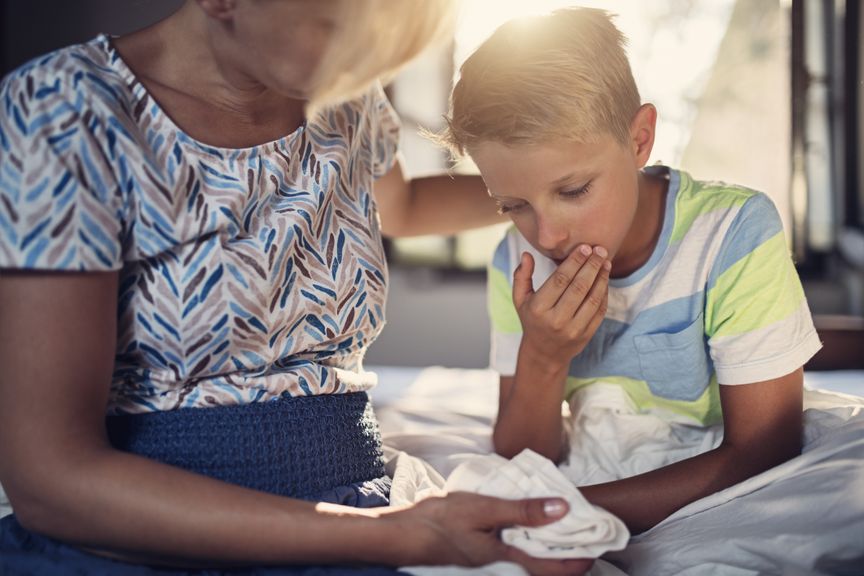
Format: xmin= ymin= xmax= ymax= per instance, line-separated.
xmin=0 ymin=271 xmax=589 ymax=574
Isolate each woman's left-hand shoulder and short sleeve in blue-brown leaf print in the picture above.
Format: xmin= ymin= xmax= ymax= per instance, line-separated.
xmin=0 ymin=37 xmax=137 ymax=270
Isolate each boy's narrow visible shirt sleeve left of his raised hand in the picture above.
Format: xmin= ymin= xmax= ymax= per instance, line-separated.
xmin=486 ymin=231 xmax=522 ymax=376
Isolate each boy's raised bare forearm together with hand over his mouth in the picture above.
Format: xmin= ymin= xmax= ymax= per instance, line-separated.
xmin=492 ymin=245 xmax=610 ymax=461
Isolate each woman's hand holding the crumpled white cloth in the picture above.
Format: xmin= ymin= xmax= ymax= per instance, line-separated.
xmin=384 ymin=492 xmax=593 ymax=576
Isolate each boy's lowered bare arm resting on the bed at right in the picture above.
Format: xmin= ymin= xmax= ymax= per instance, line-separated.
xmin=580 ymin=368 xmax=803 ymax=534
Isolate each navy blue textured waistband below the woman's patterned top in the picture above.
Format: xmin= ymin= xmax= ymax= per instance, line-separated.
xmin=106 ymin=392 xmax=384 ymax=499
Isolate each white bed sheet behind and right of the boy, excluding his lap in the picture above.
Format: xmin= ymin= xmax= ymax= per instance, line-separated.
xmin=367 ymin=366 xmax=864 ymax=576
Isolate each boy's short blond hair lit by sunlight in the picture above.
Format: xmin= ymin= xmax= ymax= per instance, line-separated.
xmin=438 ymin=8 xmax=641 ymax=156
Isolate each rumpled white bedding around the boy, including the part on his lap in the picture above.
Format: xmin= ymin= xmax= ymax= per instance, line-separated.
xmin=373 ymin=368 xmax=864 ymax=576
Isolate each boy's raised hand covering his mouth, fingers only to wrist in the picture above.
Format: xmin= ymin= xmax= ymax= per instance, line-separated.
xmin=513 ymin=244 xmax=612 ymax=364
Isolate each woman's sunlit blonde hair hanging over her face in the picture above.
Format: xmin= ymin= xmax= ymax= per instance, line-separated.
xmin=307 ymin=0 xmax=458 ymax=113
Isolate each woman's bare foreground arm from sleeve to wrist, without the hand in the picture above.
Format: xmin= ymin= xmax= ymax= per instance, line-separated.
xmin=0 ymin=272 xmax=385 ymax=563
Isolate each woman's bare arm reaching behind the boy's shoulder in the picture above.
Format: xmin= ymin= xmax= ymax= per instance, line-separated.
xmin=374 ymin=156 xmax=505 ymax=237
